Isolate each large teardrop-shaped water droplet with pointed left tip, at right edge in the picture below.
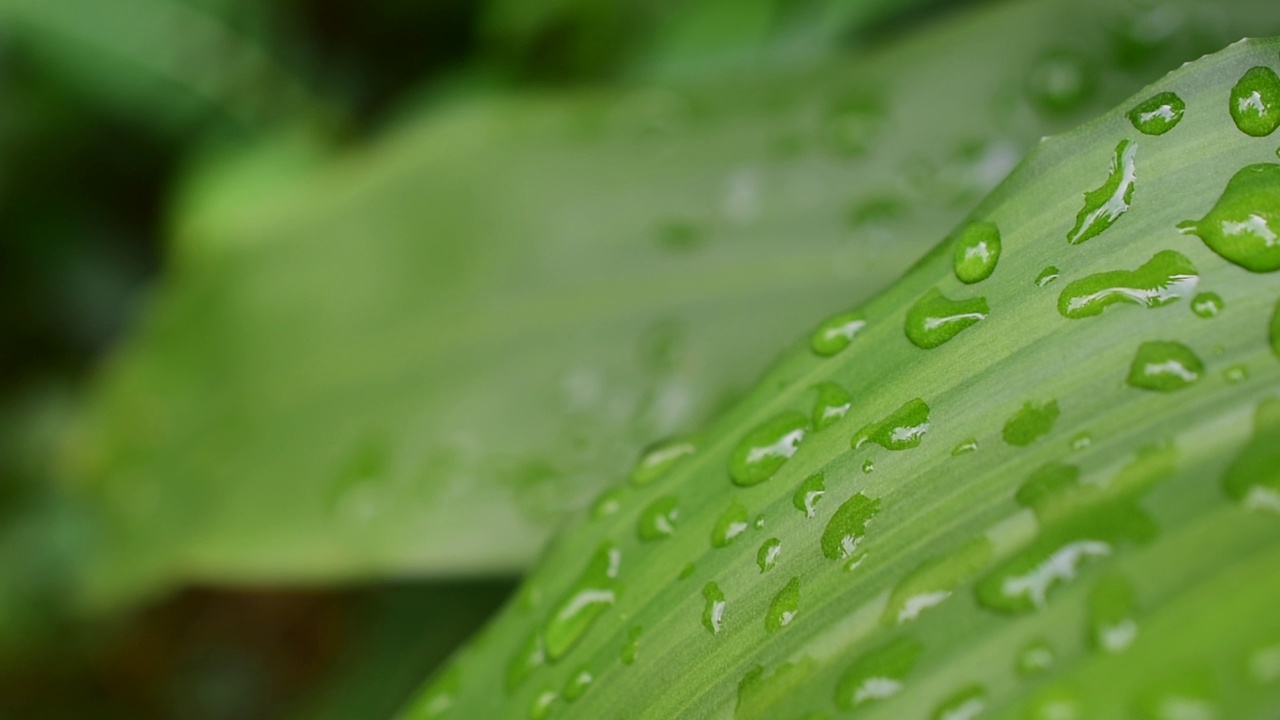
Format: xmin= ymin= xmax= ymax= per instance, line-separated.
xmin=1178 ymin=163 xmax=1280 ymax=273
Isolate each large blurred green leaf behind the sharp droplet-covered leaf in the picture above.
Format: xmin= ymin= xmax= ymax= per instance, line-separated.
xmin=55 ymin=0 xmax=1280 ymax=602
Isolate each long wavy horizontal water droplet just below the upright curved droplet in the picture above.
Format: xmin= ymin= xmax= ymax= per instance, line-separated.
xmin=1057 ymin=250 xmax=1199 ymax=320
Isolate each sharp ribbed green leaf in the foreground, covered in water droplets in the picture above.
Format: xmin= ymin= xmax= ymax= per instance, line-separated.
xmin=403 ymin=35 xmax=1280 ymax=720
